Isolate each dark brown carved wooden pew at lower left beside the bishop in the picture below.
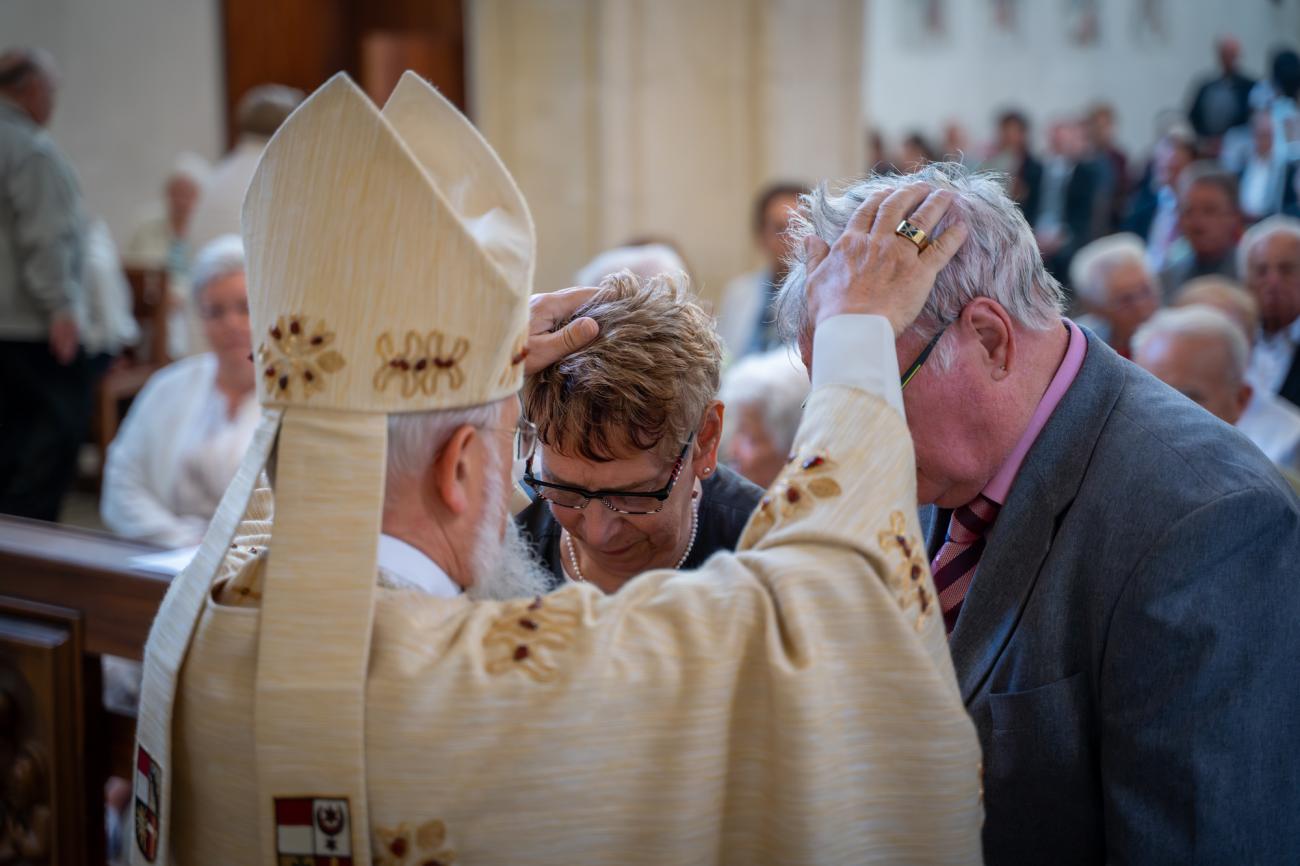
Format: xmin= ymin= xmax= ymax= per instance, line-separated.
xmin=0 ymin=516 xmax=169 ymax=866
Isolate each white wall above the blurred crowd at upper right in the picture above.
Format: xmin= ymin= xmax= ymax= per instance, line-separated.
xmin=863 ymin=0 xmax=1300 ymax=165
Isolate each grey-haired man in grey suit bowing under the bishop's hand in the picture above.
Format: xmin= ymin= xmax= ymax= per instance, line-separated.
xmin=780 ymin=159 xmax=1300 ymax=863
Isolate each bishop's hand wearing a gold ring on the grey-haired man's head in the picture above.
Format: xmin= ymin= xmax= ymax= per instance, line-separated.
xmin=806 ymin=183 xmax=967 ymax=337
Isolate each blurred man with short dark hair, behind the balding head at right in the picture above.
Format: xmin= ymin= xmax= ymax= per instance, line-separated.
xmin=1160 ymin=161 xmax=1244 ymax=296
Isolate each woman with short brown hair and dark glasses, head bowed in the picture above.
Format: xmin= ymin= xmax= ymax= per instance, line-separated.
xmin=516 ymin=273 xmax=762 ymax=593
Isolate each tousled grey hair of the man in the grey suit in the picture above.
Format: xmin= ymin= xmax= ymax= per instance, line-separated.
xmin=777 ymin=163 xmax=1065 ymax=369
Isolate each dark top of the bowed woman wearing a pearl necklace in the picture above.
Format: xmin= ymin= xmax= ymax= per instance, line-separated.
xmin=515 ymin=466 xmax=763 ymax=589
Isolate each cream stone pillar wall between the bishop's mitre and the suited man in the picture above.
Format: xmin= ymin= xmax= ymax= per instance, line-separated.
xmin=468 ymin=0 xmax=863 ymax=306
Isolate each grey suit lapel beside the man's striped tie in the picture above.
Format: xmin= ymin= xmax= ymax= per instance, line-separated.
xmin=949 ymin=330 xmax=1127 ymax=702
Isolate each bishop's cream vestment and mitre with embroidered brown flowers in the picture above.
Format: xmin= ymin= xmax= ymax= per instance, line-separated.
xmin=133 ymin=74 xmax=982 ymax=866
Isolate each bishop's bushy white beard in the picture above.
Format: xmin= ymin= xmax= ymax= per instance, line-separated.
xmin=465 ymin=454 xmax=550 ymax=601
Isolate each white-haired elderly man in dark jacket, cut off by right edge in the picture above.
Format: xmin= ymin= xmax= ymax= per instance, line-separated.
xmin=1239 ymin=216 xmax=1300 ymax=406
